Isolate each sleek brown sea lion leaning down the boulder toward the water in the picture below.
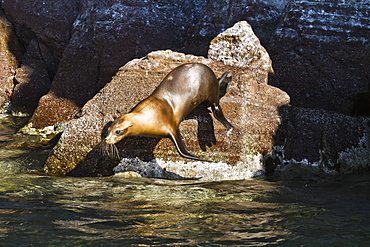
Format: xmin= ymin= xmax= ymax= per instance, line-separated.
xmin=103 ymin=63 xmax=233 ymax=161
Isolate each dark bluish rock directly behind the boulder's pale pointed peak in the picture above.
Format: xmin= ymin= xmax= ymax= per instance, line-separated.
xmin=181 ymin=0 xmax=289 ymax=56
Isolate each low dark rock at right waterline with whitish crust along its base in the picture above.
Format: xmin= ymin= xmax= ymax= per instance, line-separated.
xmin=264 ymin=106 xmax=370 ymax=178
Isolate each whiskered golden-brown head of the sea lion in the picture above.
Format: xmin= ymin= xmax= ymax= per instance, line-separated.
xmin=104 ymin=115 xmax=132 ymax=144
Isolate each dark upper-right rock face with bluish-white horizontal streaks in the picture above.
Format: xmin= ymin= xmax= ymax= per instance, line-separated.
xmin=268 ymin=0 xmax=370 ymax=116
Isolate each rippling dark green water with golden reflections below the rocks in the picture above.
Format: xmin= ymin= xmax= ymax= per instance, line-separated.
xmin=0 ymin=115 xmax=370 ymax=246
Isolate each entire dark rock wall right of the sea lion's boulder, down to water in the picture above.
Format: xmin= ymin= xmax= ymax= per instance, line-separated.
xmin=264 ymin=0 xmax=370 ymax=178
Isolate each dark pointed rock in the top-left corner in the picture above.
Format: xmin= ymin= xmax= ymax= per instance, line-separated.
xmin=1 ymin=0 xmax=80 ymax=64
